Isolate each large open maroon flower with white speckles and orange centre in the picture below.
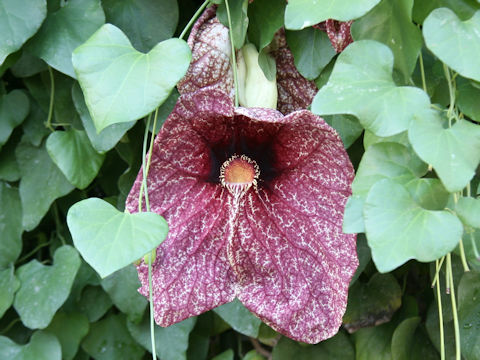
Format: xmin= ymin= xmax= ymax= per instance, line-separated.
xmin=127 ymin=89 xmax=358 ymax=343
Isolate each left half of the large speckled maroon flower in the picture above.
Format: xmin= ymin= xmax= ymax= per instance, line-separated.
xmin=127 ymin=91 xmax=236 ymax=326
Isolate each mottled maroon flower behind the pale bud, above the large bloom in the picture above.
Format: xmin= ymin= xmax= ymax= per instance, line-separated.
xmin=177 ymin=6 xmax=317 ymax=114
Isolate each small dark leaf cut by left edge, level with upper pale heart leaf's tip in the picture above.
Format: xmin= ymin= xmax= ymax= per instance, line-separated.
xmin=0 ymin=90 xmax=30 ymax=149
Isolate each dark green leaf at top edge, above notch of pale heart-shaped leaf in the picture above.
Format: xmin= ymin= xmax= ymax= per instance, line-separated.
xmin=102 ymin=0 xmax=178 ymax=52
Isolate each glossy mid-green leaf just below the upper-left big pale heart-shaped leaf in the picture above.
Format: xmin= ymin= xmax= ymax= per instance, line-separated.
xmin=46 ymin=129 xmax=105 ymax=189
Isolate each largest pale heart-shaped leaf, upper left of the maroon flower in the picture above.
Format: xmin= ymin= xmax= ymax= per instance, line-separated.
xmin=73 ymin=24 xmax=191 ymax=132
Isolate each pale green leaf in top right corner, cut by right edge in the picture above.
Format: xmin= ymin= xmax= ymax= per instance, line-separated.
xmin=423 ymin=8 xmax=480 ymax=81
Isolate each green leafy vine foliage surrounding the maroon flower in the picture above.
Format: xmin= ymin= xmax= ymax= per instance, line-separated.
xmin=0 ymin=0 xmax=480 ymax=360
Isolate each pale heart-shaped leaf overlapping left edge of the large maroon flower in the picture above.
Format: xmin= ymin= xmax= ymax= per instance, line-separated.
xmin=67 ymin=198 xmax=168 ymax=278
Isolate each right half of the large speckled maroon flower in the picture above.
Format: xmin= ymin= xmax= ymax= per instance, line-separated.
xmin=227 ymin=111 xmax=358 ymax=343
